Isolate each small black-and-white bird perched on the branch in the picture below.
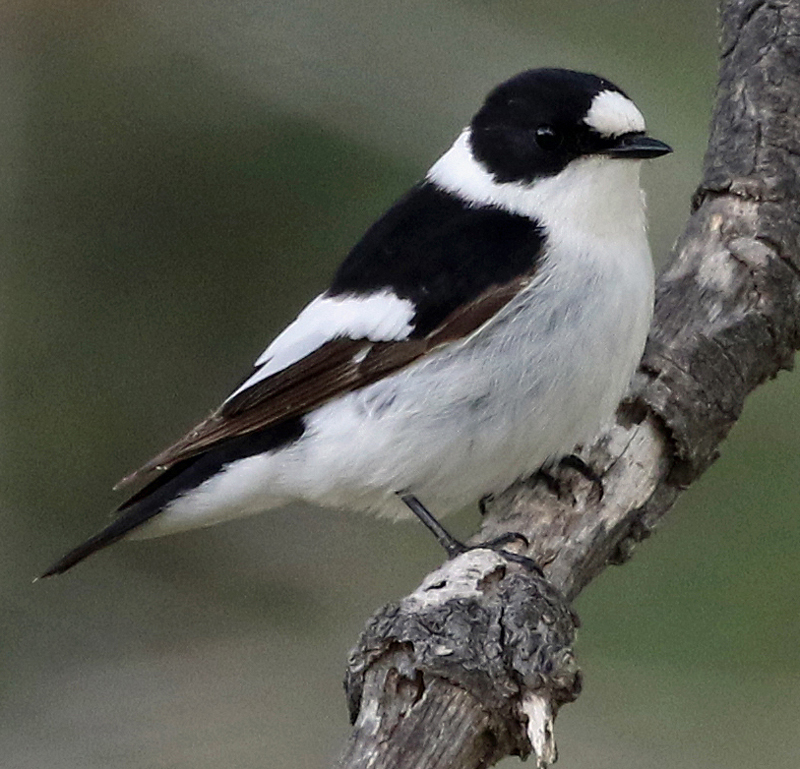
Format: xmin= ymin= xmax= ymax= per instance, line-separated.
xmin=42 ymin=68 xmax=672 ymax=576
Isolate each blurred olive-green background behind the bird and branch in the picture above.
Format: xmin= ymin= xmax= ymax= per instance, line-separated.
xmin=0 ymin=0 xmax=800 ymax=769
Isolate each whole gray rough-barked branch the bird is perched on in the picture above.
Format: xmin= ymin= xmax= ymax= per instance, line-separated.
xmin=336 ymin=0 xmax=800 ymax=769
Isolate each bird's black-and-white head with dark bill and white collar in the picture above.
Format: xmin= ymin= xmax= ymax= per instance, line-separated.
xmin=427 ymin=69 xmax=672 ymax=237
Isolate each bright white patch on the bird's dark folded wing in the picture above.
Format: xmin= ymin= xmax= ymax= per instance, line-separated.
xmin=225 ymin=291 xmax=416 ymax=403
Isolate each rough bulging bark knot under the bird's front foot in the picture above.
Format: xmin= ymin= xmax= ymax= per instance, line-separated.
xmin=345 ymin=549 xmax=580 ymax=767
